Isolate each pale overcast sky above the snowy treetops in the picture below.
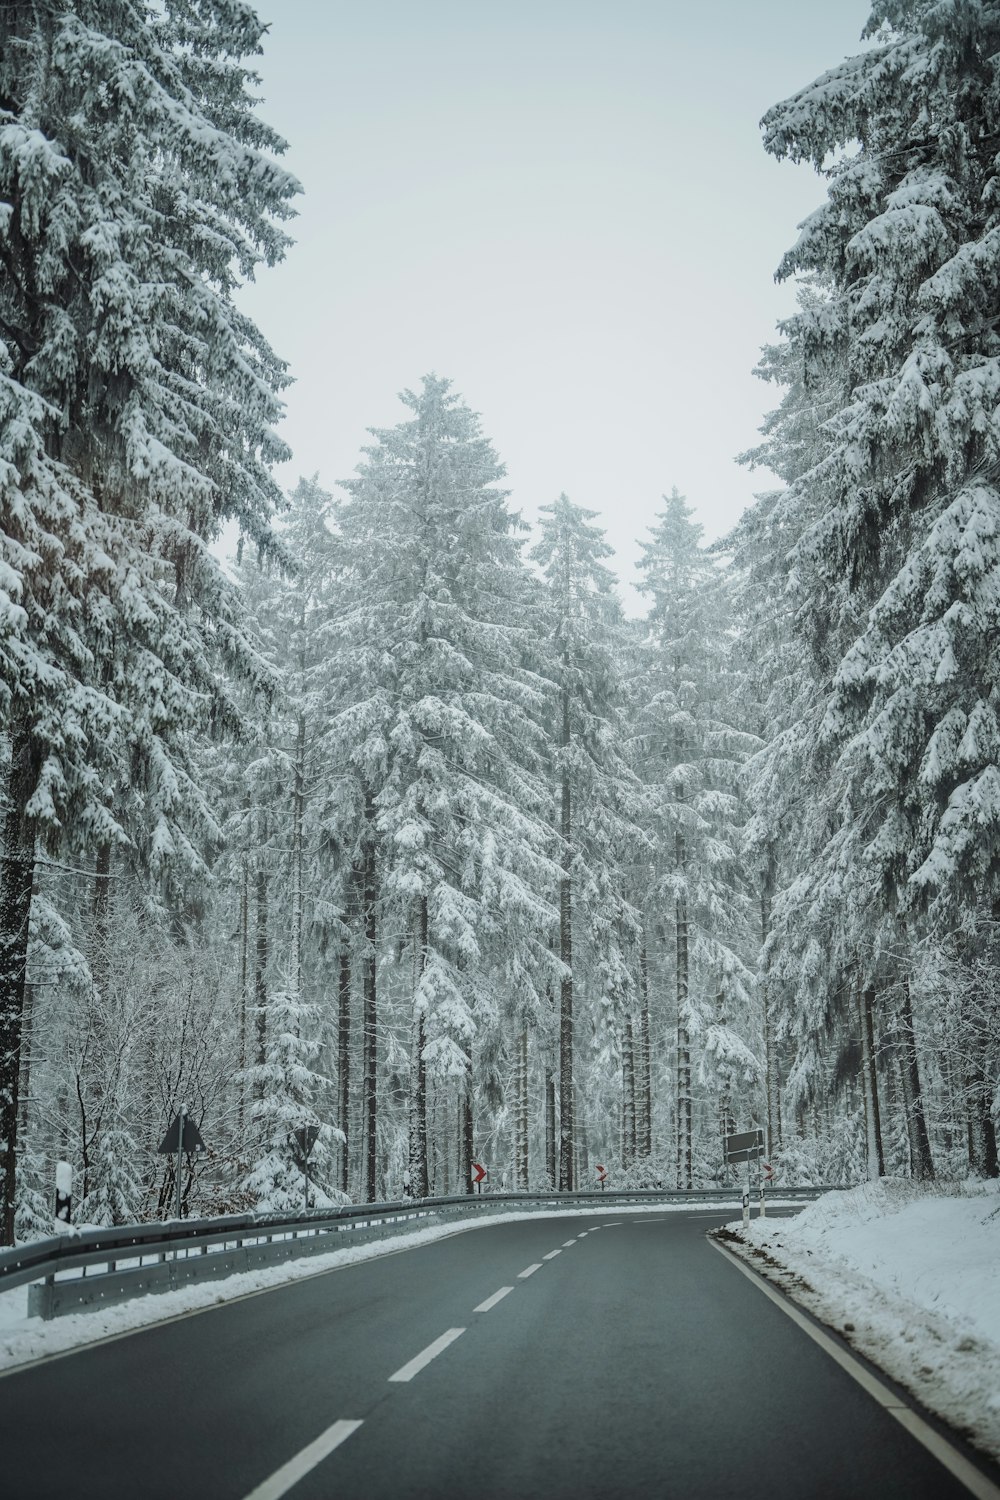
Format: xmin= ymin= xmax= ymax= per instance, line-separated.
xmin=243 ymin=0 xmax=868 ymax=605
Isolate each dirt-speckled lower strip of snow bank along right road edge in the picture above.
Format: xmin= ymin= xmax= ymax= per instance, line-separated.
xmin=712 ymin=1220 xmax=1000 ymax=1461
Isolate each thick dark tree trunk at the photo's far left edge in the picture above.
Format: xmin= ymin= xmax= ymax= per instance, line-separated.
xmin=0 ymin=732 xmax=40 ymax=1245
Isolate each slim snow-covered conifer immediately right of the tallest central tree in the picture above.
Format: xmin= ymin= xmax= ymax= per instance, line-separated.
xmin=531 ymin=495 xmax=642 ymax=1191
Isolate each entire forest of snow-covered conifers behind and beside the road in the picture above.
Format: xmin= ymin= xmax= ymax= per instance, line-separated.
xmin=0 ymin=0 xmax=1000 ymax=1242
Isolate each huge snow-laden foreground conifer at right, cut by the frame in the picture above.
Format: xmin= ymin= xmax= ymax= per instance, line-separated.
xmin=765 ymin=0 xmax=1000 ymax=1175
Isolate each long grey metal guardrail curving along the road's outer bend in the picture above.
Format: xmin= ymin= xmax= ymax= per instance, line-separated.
xmin=0 ymin=1187 xmax=829 ymax=1319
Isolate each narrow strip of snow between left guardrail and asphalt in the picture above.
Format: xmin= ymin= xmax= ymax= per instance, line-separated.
xmin=0 ymin=1202 xmax=773 ymax=1371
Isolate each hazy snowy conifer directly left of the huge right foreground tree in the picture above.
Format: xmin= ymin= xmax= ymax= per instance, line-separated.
xmin=727 ymin=301 xmax=858 ymax=1167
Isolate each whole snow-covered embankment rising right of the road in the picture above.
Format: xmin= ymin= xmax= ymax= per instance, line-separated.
xmin=720 ymin=1181 xmax=1000 ymax=1460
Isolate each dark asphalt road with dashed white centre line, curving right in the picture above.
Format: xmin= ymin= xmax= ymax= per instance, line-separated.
xmin=0 ymin=1212 xmax=989 ymax=1500
